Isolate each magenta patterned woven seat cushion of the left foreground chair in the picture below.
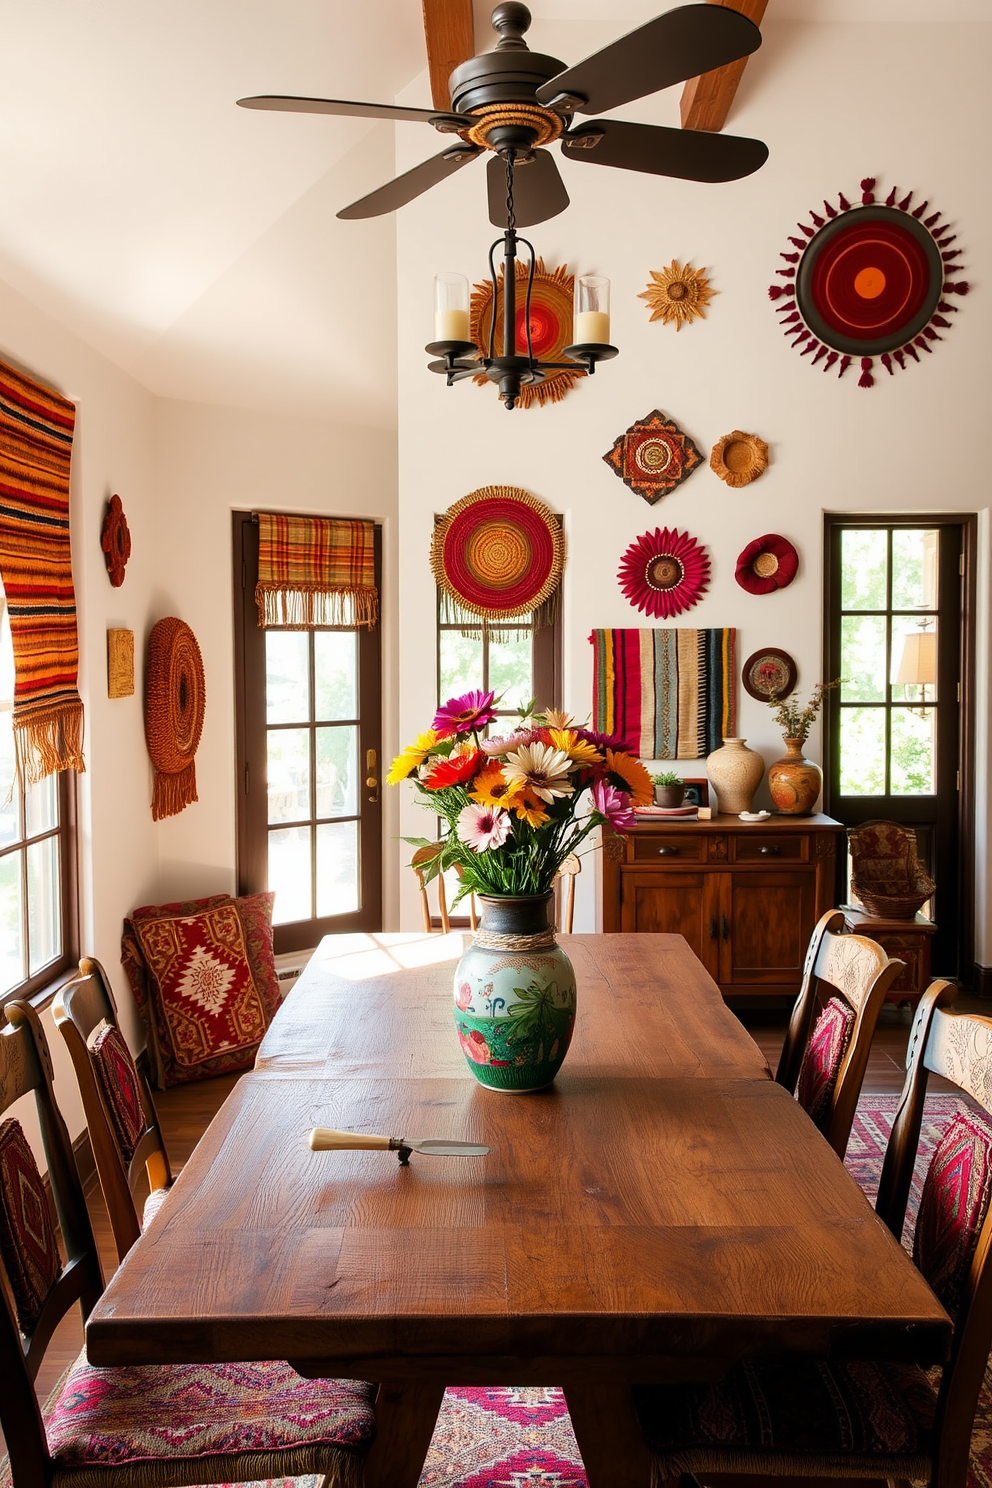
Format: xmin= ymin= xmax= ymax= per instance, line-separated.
xmin=45 ymin=1353 xmax=375 ymax=1469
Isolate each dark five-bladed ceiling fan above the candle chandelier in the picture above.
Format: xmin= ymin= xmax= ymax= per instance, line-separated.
xmin=238 ymin=0 xmax=767 ymax=228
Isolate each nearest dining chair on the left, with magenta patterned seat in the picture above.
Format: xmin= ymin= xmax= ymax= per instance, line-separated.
xmin=0 ymin=1001 xmax=375 ymax=1488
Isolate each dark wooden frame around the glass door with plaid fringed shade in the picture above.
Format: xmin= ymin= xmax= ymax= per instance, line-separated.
xmin=232 ymin=512 xmax=384 ymax=952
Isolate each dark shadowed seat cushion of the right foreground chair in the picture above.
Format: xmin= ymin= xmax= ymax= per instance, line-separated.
xmin=635 ymin=1356 xmax=935 ymax=1478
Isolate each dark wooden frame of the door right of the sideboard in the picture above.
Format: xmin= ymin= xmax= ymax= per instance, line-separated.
xmin=822 ymin=512 xmax=989 ymax=990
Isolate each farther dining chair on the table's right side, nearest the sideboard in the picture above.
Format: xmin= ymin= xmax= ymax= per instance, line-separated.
xmin=775 ymin=909 xmax=904 ymax=1158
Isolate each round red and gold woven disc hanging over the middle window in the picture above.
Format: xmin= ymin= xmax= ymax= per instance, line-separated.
xmin=431 ymin=485 xmax=565 ymax=625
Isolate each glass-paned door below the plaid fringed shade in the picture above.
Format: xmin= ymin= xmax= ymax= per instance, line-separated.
xmin=233 ymin=512 xmax=382 ymax=952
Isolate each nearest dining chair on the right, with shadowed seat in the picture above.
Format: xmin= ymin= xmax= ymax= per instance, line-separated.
xmin=634 ymin=982 xmax=992 ymax=1488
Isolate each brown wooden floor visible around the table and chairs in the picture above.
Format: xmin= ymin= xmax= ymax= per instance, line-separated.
xmin=0 ymin=997 xmax=975 ymax=1452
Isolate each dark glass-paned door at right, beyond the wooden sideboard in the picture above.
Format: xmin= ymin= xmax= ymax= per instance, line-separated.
xmin=824 ymin=516 xmax=973 ymax=976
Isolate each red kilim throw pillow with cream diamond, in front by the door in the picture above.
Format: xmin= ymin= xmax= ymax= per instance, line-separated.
xmin=132 ymin=900 xmax=271 ymax=1085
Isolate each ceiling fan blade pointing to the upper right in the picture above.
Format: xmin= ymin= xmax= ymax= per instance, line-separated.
xmin=537 ymin=4 xmax=761 ymax=113
